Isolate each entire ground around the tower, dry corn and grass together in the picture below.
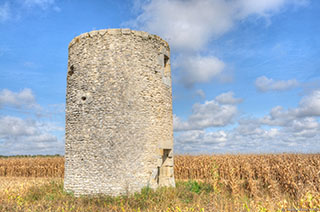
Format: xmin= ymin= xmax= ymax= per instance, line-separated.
xmin=0 ymin=154 xmax=320 ymax=212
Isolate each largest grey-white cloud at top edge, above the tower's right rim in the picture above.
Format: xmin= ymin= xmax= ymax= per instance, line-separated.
xmin=137 ymin=0 xmax=232 ymax=50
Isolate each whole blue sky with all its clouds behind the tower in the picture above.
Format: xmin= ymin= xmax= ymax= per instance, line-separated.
xmin=0 ymin=0 xmax=320 ymax=155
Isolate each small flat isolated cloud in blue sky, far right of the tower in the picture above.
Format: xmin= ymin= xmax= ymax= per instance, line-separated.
xmin=255 ymin=76 xmax=299 ymax=92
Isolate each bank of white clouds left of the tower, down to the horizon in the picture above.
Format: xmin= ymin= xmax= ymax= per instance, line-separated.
xmin=0 ymin=88 xmax=64 ymax=155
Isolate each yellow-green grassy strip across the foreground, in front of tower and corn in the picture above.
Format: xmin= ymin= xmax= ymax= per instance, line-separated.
xmin=0 ymin=178 xmax=320 ymax=212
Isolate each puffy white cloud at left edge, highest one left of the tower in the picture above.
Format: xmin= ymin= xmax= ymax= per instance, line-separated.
xmin=0 ymin=88 xmax=41 ymax=109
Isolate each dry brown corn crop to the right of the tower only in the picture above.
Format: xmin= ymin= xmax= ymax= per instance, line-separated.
xmin=175 ymin=154 xmax=320 ymax=198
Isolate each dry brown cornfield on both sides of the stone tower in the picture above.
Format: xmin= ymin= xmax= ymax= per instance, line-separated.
xmin=0 ymin=154 xmax=320 ymax=198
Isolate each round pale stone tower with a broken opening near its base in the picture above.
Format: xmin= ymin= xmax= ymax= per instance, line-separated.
xmin=64 ymin=29 xmax=175 ymax=196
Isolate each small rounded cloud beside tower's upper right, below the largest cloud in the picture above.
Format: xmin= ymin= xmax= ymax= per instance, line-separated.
xmin=177 ymin=56 xmax=225 ymax=87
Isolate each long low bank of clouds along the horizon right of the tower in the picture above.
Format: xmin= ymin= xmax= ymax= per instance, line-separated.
xmin=175 ymin=90 xmax=320 ymax=153
